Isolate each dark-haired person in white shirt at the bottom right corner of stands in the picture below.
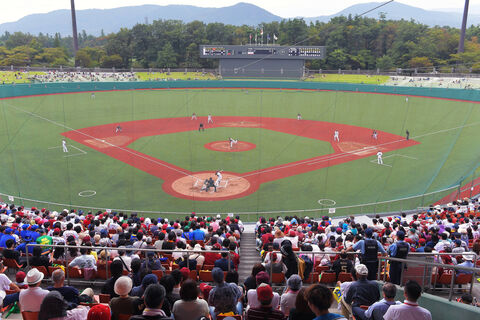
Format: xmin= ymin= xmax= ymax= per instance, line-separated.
xmin=383 ymin=280 xmax=432 ymax=320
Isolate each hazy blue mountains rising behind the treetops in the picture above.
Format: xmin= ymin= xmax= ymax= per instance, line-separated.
xmin=0 ymin=2 xmax=480 ymax=35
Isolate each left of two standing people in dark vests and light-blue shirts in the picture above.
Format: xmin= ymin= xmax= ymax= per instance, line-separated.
xmin=349 ymin=228 xmax=386 ymax=280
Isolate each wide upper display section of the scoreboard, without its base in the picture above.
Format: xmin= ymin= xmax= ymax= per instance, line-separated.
xmin=200 ymin=45 xmax=326 ymax=60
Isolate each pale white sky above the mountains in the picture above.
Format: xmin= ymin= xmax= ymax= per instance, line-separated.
xmin=0 ymin=0 xmax=480 ymax=23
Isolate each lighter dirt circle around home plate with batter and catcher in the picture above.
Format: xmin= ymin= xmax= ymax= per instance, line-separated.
xmin=171 ymin=171 xmax=254 ymax=201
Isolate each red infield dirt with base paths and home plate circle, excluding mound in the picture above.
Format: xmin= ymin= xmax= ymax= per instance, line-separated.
xmin=62 ymin=116 xmax=419 ymax=201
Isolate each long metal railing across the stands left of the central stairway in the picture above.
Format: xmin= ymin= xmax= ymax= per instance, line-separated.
xmin=25 ymin=243 xmax=232 ymax=285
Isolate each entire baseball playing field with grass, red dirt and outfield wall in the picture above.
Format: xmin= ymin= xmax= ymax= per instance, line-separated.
xmin=0 ymin=80 xmax=480 ymax=220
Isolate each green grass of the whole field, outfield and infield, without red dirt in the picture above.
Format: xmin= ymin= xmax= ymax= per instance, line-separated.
xmin=0 ymin=89 xmax=480 ymax=219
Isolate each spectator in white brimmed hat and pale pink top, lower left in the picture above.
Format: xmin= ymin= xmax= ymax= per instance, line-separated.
xmin=19 ymin=268 xmax=49 ymax=312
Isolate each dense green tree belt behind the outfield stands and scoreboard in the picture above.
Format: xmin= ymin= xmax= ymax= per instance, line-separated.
xmin=0 ymin=17 xmax=480 ymax=71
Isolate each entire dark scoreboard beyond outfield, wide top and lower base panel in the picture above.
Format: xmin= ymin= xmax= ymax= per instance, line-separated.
xmin=200 ymin=45 xmax=326 ymax=79
